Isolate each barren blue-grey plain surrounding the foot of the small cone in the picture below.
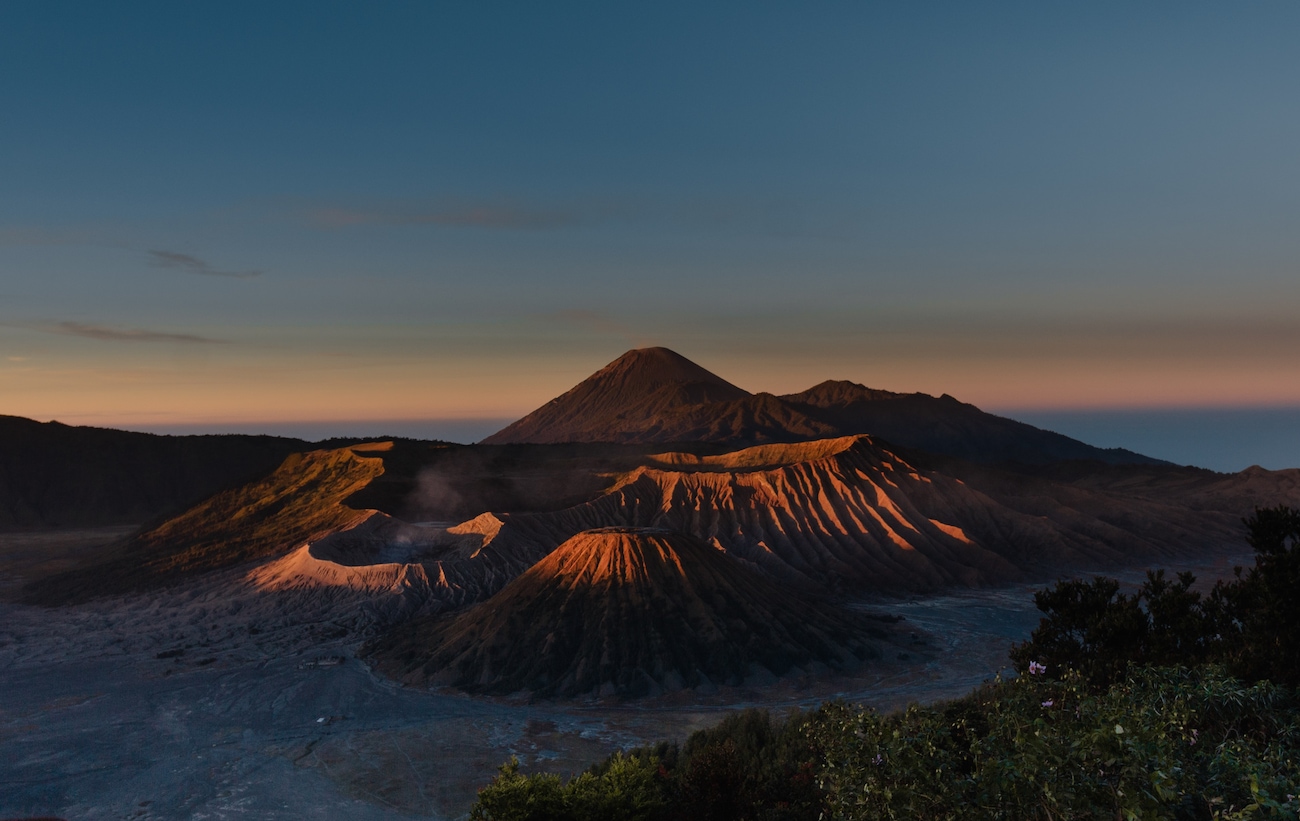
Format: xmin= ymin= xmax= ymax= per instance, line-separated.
xmin=0 ymin=533 xmax=1248 ymax=818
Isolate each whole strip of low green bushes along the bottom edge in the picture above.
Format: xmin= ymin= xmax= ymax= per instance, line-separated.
xmin=471 ymin=665 xmax=1300 ymax=821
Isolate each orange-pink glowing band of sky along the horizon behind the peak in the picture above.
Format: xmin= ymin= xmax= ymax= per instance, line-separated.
xmin=0 ymin=345 xmax=1300 ymax=427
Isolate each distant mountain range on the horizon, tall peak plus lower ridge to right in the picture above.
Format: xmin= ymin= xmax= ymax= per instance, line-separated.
xmin=484 ymin=348 xmax=1165 ymax=465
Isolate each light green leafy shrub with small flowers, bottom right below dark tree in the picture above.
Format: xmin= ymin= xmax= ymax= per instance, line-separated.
xmin=810 ymin=668 xmax=1300 ymax=820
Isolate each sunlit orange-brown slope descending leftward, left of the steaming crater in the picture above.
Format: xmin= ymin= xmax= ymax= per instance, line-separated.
xmin=25 ymin=443 xmax=386 ymax=604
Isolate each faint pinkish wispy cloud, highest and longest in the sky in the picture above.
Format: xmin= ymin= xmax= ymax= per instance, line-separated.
xmin=308 ymin=204 xmax=581 ymax=231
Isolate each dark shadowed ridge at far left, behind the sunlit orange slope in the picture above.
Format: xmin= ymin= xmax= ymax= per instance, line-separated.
xmin=0 ymin=416 xmax=311 ymax=529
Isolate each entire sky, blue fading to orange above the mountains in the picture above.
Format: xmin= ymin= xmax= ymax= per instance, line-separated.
xmin=0 ymin=0 xmax=1300 ymax=466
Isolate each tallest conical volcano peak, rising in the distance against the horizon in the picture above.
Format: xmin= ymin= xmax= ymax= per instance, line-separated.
xmin=484 ymin=348 xmax=749 ymax=444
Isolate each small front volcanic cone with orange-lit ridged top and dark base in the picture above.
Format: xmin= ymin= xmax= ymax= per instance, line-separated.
xmin=367 ymin=527 xmax=884 ymax=696
